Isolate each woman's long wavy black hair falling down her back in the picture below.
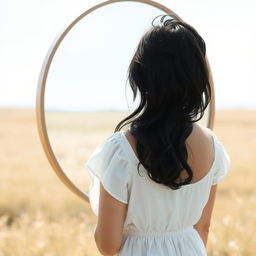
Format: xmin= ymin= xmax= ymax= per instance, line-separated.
xmin=115 ymin=15 xmax=211 ymax=189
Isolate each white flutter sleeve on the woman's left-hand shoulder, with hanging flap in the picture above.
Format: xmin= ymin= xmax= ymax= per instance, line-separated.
xmin=84 ymin=133 xmax=129 ymax=216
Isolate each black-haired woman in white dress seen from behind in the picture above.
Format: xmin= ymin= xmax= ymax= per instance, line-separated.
xmin=86 ymin=16 xmax=230 ymax=256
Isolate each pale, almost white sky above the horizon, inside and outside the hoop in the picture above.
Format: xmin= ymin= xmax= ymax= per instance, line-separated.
xmin=0 ymin=0 xmax=256 ymax=110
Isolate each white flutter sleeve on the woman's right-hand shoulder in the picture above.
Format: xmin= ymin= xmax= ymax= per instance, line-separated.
xmin=212 ymin=134 xmax=230 ymax=185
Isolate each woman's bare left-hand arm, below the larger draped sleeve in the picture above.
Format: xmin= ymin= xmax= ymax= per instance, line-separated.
xmin=94 ymin=183 xmax=127 ymax=256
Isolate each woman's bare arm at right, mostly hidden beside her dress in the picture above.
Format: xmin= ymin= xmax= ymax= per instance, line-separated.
xmin=194 ymin=184 xmax=217 ymax=247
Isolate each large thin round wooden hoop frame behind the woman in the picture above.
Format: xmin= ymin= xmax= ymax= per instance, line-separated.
xmin=36 ymin=0 xmax=215 ymax=202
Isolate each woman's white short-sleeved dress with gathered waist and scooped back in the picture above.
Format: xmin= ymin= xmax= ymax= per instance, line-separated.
xmin=85 ymin=129 xmax=230 ymax=256
